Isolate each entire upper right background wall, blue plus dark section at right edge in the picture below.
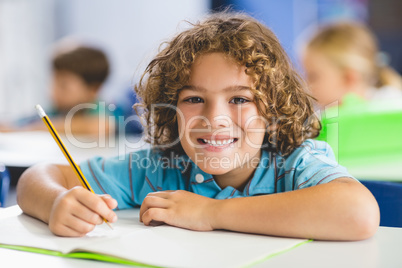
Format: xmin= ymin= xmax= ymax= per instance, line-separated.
xmin=211 ymin=0 xmax=402 ymax=74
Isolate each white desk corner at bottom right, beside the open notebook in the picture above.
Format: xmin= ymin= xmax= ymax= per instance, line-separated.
xmin=255 ymin=227 xmax=402 ymax=268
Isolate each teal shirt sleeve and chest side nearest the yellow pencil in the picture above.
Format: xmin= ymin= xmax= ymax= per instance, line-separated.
xmin=80 ymin=149 xmax=190 ymax=209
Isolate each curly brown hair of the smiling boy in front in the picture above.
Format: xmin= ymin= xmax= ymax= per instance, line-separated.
xmin=135 ymin=11 xmax=321 ymax=155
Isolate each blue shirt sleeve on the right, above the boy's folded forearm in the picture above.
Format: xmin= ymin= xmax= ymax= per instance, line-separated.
xmin=286 ymin=140 xmax=354 ymax=190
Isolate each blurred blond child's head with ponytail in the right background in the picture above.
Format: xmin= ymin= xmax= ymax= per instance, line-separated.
xmin=302 ymin=22 xmax=402 ymax=107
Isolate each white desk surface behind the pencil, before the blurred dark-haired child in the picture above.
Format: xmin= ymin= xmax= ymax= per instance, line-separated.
xmin=0 ymin=131 xmax=149 ymax=167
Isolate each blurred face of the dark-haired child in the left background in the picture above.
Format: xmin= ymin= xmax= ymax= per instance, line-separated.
xmin=51 ymin=71 xmax=97 ymax=112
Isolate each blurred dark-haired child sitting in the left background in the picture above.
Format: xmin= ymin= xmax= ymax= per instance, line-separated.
xmin=0 ymin=44 xmax=114 ymax=136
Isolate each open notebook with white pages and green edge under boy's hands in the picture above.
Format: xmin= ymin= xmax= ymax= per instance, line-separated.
xmin=0 ymin=206 xmax=310 ymax=268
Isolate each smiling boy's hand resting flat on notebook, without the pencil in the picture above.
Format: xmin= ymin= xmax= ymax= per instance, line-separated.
xmin=140 ymin=190 xmax=218 ymax=231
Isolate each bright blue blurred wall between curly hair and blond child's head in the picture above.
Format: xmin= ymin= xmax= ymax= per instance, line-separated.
xmin=212 ymin=0 xmax=368 ymax=71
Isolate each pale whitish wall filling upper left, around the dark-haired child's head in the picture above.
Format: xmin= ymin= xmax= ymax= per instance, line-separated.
xmin=0 ymin=0 xmax=210 ymax=120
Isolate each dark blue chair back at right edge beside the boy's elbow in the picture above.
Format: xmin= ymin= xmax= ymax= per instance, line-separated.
xmin=361 ymin=181 xmax=402 ymax=227
